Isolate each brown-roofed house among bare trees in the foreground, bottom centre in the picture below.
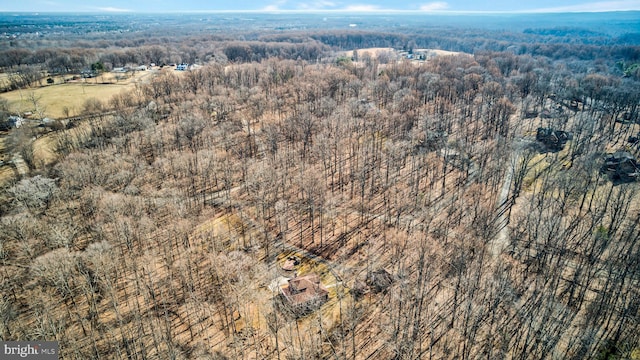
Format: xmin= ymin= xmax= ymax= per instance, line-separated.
xmin=280 ymin=274 xmax=329 ymax=314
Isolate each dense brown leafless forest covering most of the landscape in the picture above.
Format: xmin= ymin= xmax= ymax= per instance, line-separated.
xmin=0 ymin=11 xmax=640 ymax=359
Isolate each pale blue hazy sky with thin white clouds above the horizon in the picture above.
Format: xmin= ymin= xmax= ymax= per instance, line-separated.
xmin=0 ymin=0 xmax=640 ymax=12
